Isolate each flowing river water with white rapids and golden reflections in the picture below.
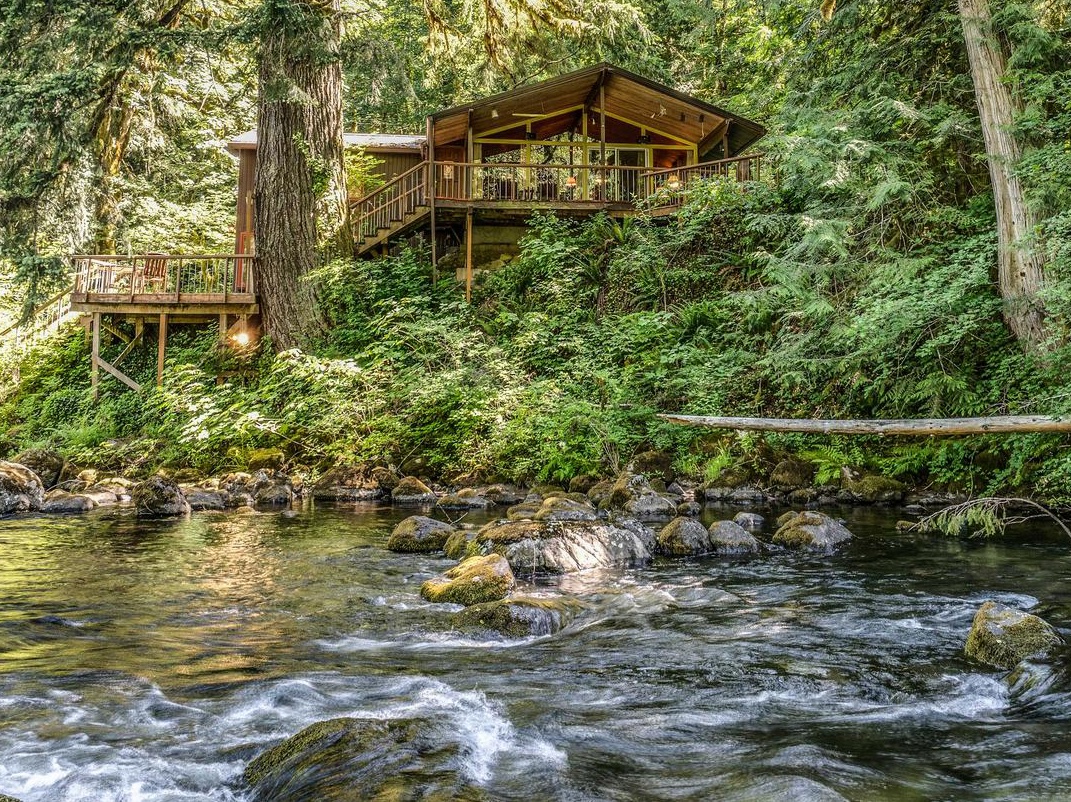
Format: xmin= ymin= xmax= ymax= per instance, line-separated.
xmin=0 ymin=508 xmax=1071 ymax=802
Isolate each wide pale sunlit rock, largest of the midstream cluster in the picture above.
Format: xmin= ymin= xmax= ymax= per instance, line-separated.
xmin=471 ymin=520 xmax=651 ymax=575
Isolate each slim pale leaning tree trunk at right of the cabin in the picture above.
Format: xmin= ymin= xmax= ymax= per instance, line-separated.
xmin=959 ymin=0 xmax=1044 ymax=348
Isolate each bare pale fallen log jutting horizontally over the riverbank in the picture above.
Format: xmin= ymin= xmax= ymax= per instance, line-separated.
xmin=659 ymin=414 xmax=1071 ymax=435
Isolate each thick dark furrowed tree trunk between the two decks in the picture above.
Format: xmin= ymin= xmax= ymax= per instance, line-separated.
xmin=254 ymin=0 xmax=353 ymax=350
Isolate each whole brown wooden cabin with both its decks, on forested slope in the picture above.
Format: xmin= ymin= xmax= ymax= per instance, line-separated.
xmin=70 ymin=63 xmax=766 ymax=389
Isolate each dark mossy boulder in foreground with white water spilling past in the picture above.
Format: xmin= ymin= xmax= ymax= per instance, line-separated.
xmin=242 ymin=718 xmax=481 ymax=802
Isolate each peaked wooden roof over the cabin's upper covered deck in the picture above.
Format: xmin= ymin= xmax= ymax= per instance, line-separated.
xmin=431 ymin=62 xmax=766 ymax=157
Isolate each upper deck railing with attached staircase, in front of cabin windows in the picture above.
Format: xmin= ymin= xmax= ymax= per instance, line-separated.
xmin=351 ymin=154 xmax=761 ymax=254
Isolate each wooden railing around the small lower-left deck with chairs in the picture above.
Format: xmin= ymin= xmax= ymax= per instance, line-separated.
xmin=71 ymin=254 xmax=256 ymax=303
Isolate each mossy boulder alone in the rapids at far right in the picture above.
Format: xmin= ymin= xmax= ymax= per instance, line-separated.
xmin=964 ymin=602 xmax=1062 ymax=669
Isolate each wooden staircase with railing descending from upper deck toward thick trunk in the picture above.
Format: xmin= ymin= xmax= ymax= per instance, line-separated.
xmin=350 ymin=162 xmax=431 ymax=256
